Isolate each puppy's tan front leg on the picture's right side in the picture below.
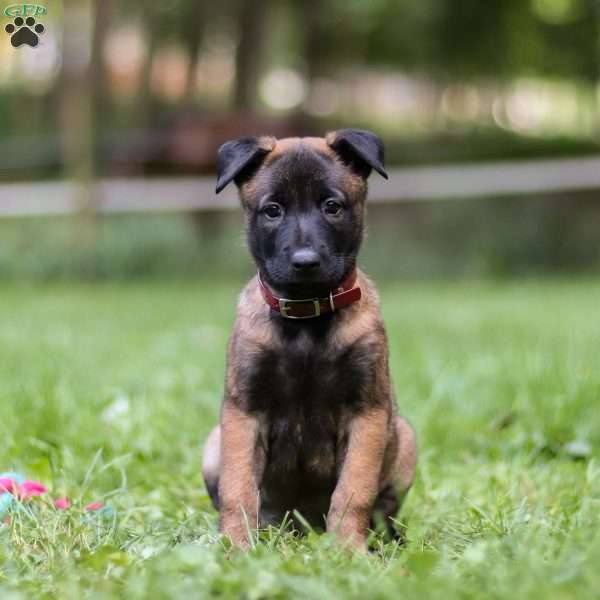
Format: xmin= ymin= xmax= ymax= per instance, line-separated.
xmin=327 ymin=408 xmax=388 ymax=550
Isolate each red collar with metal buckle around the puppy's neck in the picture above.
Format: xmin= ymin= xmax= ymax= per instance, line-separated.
xmin=258 ymin=268 xmax=362 ymax=319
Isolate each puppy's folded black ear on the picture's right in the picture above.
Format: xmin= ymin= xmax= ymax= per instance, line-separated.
xmin=325 ymin=129 xmax=388 ymax=179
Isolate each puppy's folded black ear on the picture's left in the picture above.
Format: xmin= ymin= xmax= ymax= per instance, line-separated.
xmin=216 ymin=136 xmax=276 ymax=194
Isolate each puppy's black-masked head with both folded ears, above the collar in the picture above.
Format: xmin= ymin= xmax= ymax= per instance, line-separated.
xmin=217 ymin=129 xmax=387 ymax=298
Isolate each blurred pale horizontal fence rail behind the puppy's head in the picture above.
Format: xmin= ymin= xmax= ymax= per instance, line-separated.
xmin=0 ymin=157 xmax=600 ymax=217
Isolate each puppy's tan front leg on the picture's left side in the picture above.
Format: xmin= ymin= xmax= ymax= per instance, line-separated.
xmin=219 ymin=402 xmax=264 ymax=548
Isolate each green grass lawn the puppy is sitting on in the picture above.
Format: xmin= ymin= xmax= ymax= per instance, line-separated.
xmin=0 ymin=280 xmax=600 ymax=600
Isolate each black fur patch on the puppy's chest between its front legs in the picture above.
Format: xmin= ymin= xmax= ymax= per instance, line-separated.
xmin=249 ymin=336 xmax=370 ymax=479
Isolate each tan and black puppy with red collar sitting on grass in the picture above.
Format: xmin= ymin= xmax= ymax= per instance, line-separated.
xmin=203 ymin=129 xmax=417 ymax=549
